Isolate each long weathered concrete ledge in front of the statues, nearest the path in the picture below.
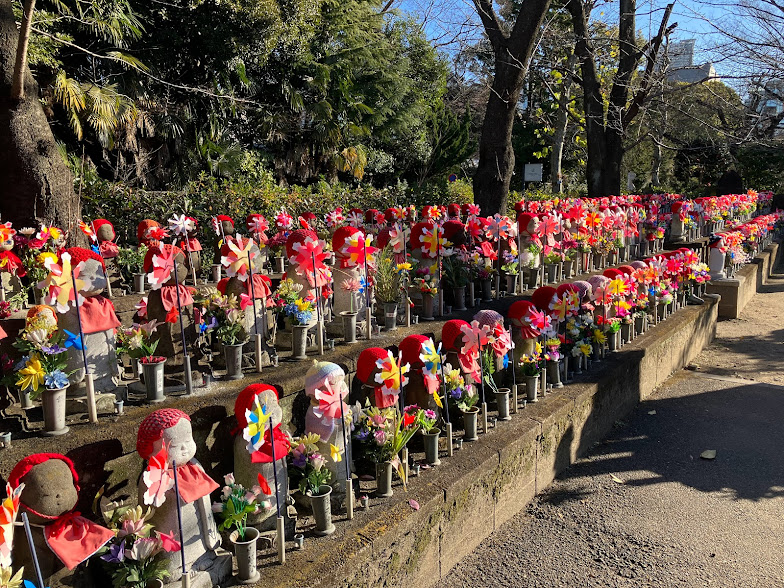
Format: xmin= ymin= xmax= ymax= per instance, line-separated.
xmin=253 ymin=296 xmax=719 ymax=588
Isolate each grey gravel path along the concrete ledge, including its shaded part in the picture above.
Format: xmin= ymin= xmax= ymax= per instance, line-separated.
xmin=438 ymin=258 xmax=784 ymax=588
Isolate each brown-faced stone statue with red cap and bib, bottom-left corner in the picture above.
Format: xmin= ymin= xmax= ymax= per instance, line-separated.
xmin=8 ymin=453 xmax=114 ymax=586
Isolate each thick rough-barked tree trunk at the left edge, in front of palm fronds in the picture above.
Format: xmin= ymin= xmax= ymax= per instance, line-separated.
xmin=0 ymin=0 xmax=81 ymax=238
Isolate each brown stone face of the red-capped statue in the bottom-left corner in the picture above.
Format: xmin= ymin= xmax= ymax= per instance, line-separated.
xmin=21 ymin=459 xmax=79 ymax=519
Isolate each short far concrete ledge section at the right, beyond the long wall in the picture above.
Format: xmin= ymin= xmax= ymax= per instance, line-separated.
xmin=707 ymin=243 xmax=779 ymax=319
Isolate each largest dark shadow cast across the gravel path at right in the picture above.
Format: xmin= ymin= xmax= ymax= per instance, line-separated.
xmin=562 ymin=382 xmax=784 ymax=501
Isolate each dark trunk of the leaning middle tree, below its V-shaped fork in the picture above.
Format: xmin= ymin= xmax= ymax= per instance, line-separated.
xmin=474 ymin=57 xmax=525 ymax=215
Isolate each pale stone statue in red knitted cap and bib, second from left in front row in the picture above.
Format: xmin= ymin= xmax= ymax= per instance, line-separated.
xmin=136 ymin=408 xmax=225 ymax=585
